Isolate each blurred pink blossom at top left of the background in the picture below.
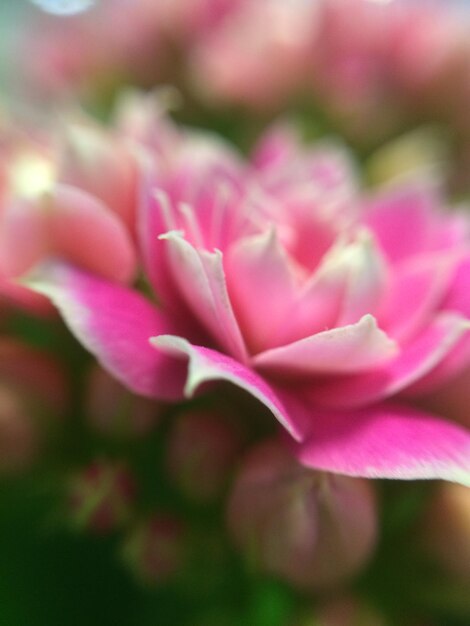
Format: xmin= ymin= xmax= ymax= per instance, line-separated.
xmin=15 ymin=0 xmax=240 ymax=97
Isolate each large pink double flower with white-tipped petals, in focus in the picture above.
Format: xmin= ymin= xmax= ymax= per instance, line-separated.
xmin=25 ymin=108 xmax=470 ymax=484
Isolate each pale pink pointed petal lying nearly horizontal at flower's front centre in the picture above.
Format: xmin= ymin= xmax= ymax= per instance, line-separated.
xmin=253 ymin=315 xmax=398 ymax=374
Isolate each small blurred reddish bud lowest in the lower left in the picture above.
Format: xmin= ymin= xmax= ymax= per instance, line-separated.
xmin=123 ymin=514 xmax=184 ymax=584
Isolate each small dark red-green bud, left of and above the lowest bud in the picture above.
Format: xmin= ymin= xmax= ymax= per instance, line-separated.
xmin=69 ymin=461 xmax=136 ymax=533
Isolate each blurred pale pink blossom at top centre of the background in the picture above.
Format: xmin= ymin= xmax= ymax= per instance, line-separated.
xmin=190 ymin=0 xmax=319 ymax=109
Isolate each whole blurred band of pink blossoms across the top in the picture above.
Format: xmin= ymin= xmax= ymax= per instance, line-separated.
xmin=16 ymin=0 xmax=470 ymax=141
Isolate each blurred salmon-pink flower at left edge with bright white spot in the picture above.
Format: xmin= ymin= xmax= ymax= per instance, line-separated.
xmin=0 ymin=112 xmax=140 ymax=285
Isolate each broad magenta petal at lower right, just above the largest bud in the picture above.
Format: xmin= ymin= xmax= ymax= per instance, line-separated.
xmin=297 ymin=405 xmax=470 ymax=486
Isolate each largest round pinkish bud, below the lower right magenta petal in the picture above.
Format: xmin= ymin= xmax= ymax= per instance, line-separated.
xmin=228 ymin=441 xmax=377 ymax=589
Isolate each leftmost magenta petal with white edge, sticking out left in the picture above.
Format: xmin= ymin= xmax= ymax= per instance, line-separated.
xmin=24 ymin=265 xmax=185 ymax=400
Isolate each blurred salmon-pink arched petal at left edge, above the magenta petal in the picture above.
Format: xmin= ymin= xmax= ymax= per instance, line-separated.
xmin=0 ymin=185 xmax=136 ymax=282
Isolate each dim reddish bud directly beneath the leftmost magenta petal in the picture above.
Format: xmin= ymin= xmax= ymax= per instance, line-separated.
xmin=86 ymin=365 xmax=159 ymax=437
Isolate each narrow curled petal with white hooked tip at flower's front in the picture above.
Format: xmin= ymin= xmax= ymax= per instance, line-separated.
xmin=151 ymin=335 xmax=305 ymax=440
